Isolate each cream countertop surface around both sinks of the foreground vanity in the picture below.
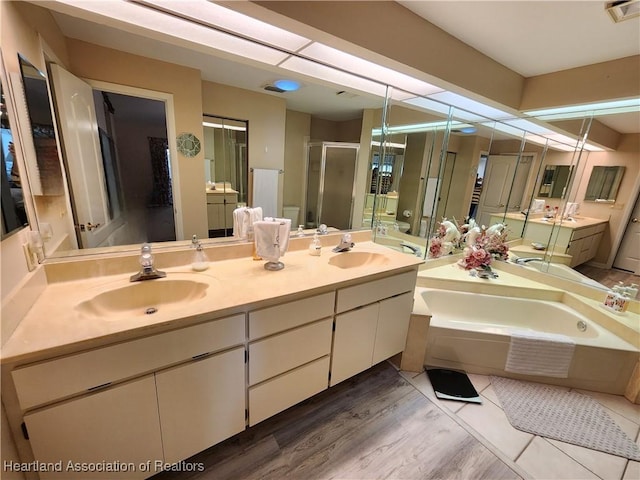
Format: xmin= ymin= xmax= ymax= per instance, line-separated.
xmin=1 ymin=241 xmax=423 ymax=364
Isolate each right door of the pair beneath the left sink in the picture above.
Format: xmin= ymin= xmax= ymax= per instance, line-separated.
xmin=156 ymin=347 xmax=246 ymax=463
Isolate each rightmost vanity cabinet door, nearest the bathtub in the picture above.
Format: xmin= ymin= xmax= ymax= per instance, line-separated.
xmin=372 ymin=292 xmax=413 ymax=365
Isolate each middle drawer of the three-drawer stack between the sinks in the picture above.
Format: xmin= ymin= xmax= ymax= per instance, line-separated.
xmin=249 ymin=318 xmax=333 ymax=385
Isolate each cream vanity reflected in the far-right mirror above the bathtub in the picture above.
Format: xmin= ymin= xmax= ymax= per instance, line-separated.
xmin=491 ymin=213 xmax=609 ymax=267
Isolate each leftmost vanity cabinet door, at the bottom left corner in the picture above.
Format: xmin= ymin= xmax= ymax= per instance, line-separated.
xmin=24 ymin=375 xmax=163 ymax=480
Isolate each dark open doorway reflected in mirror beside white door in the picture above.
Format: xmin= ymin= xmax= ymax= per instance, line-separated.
xmin=94 ymin=89 xmax=176 ymax=245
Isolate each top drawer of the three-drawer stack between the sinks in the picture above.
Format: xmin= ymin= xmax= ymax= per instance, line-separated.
xmin=249 ymin=292 xmax=335 ymax=340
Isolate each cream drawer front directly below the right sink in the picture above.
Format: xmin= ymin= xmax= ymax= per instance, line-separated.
xmin=336 ymin=270 xmax=418 ymax=313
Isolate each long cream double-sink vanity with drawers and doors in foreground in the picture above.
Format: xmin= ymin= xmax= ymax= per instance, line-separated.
xmin=2 ymin=238 xmax=422 ymax=479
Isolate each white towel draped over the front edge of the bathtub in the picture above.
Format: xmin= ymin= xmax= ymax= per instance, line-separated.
xmin=504 ymin=330 xmax=576 ymax=378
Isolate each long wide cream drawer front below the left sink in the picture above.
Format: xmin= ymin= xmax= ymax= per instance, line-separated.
xmin=11 ymin=314 xmax=245 ymax=410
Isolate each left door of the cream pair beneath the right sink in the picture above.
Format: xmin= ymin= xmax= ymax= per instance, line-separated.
xmin=330 ymin=303 xmax=379 ymax=386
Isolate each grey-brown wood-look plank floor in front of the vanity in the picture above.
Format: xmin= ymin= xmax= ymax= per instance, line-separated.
xmin=153 ymin=362 xmax=522 ymax=480
